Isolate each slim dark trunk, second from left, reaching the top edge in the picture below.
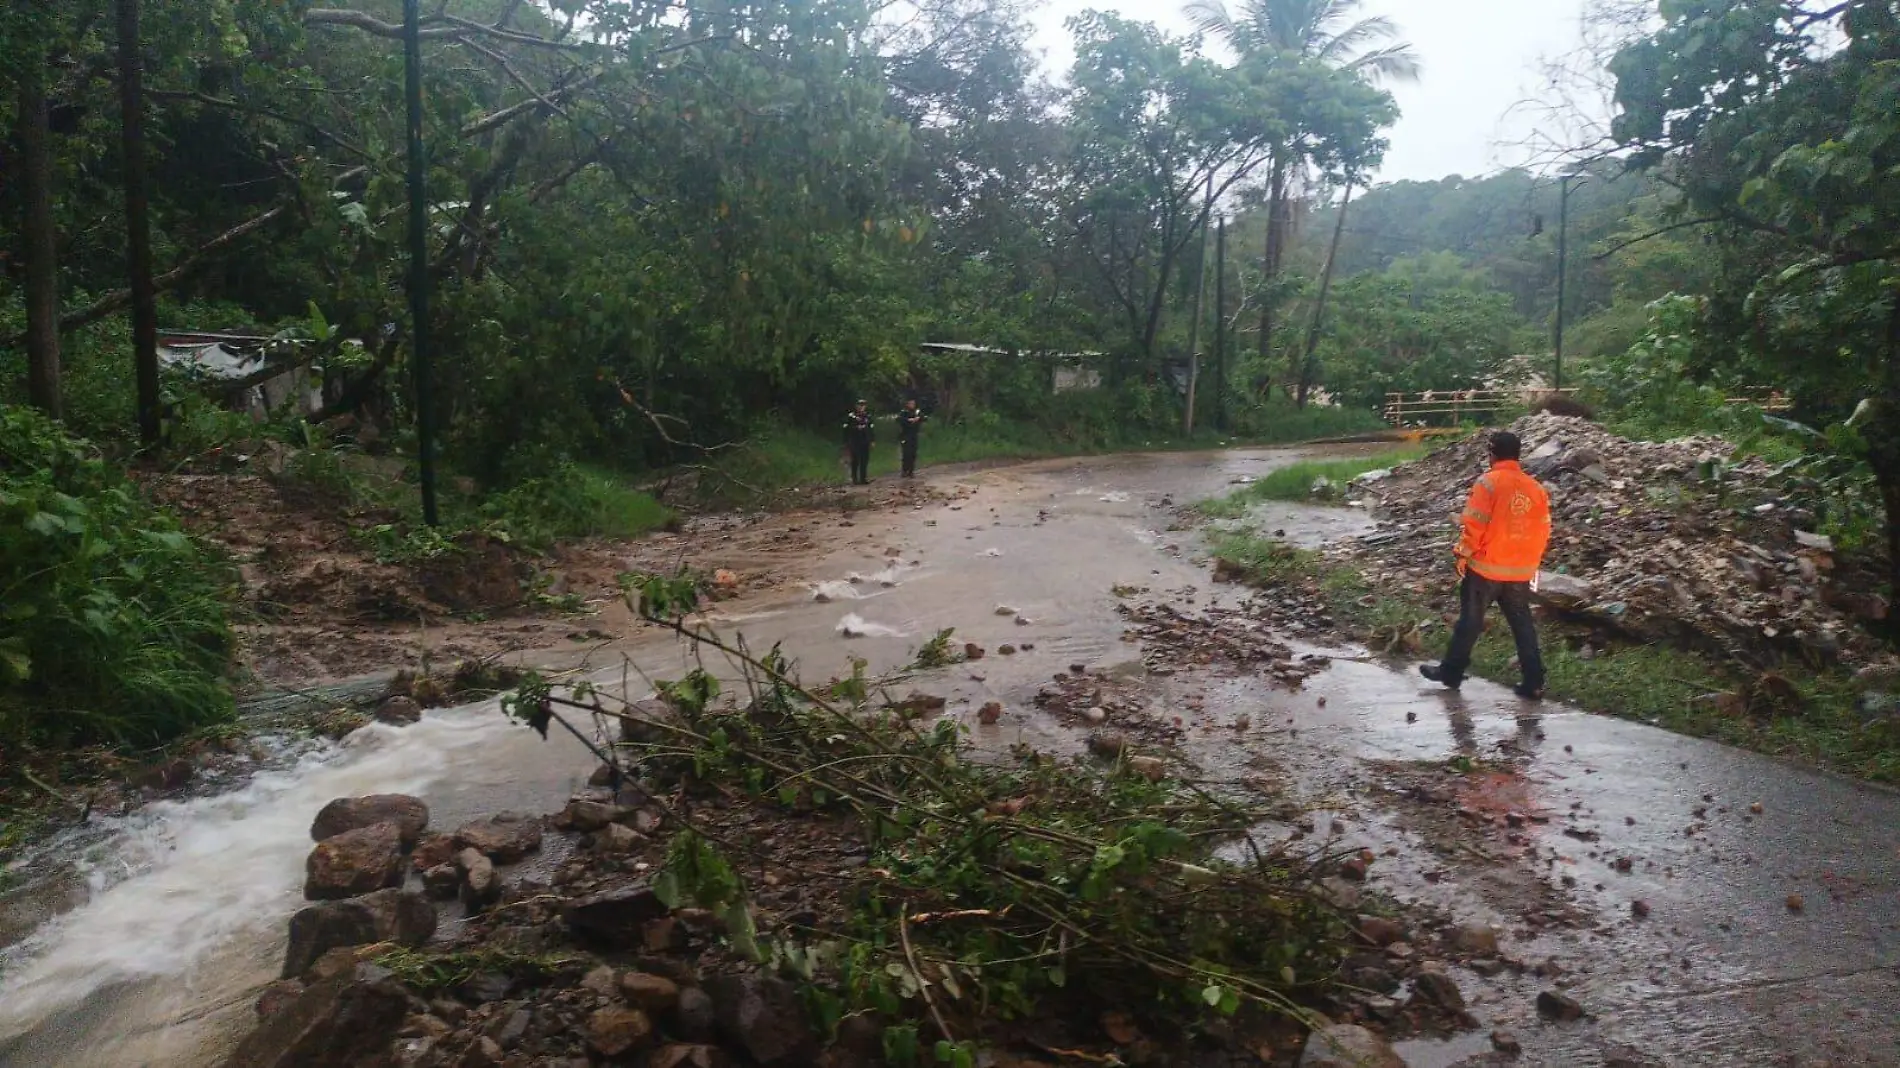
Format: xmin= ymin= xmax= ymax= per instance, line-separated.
xmin=118 ymin=0 xmax=163 ymax=448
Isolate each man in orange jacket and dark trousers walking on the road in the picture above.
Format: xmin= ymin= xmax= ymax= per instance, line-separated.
xmin=1419 ymin=429 xmax=1550 ymax=701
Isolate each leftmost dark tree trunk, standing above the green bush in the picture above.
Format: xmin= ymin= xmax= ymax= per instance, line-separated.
xmin=15 ymin=55 xmax=61 ymax=420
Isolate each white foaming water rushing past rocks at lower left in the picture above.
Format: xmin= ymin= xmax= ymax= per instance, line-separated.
xmin=0 ymin=701 xmax=521 ymax=1039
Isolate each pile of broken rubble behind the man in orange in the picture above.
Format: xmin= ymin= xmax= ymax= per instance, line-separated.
xmin=1336 ymin=412 xmax=1889 ymax=665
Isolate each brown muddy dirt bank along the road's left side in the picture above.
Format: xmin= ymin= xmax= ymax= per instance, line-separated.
xmin=146 ymin=473 xmax=946 ymax=690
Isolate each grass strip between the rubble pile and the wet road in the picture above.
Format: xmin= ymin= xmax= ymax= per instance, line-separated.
xmin=1214 ymin=534 xmax=1900 ymax=783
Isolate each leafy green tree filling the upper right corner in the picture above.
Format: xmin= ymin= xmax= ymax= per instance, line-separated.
xmin=1611 ymin=0 xmax=1900 ymax=595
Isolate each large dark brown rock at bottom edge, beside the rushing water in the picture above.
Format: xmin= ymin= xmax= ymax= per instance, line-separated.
xmin=224 ymin=965 xmax=409 ymax=1068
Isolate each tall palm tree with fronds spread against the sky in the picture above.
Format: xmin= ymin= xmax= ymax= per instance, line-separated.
xmin=1184 ymin=0 xmax=1419 ymax=393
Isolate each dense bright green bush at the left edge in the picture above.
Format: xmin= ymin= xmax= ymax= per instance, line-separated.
xmin=0 ymin=407 xmax=232 ymax=745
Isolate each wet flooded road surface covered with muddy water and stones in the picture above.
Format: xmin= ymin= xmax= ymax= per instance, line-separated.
xmin=0 ymin=442 xmax=1900 ymax=1066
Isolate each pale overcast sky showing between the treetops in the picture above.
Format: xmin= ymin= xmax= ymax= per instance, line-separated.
xmin=1032 ymin=0 xmax=1585 ymax=181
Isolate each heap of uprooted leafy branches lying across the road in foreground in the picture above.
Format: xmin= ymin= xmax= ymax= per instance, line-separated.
xmin=507 ymin=578 xmax=1345 ymax=1064
